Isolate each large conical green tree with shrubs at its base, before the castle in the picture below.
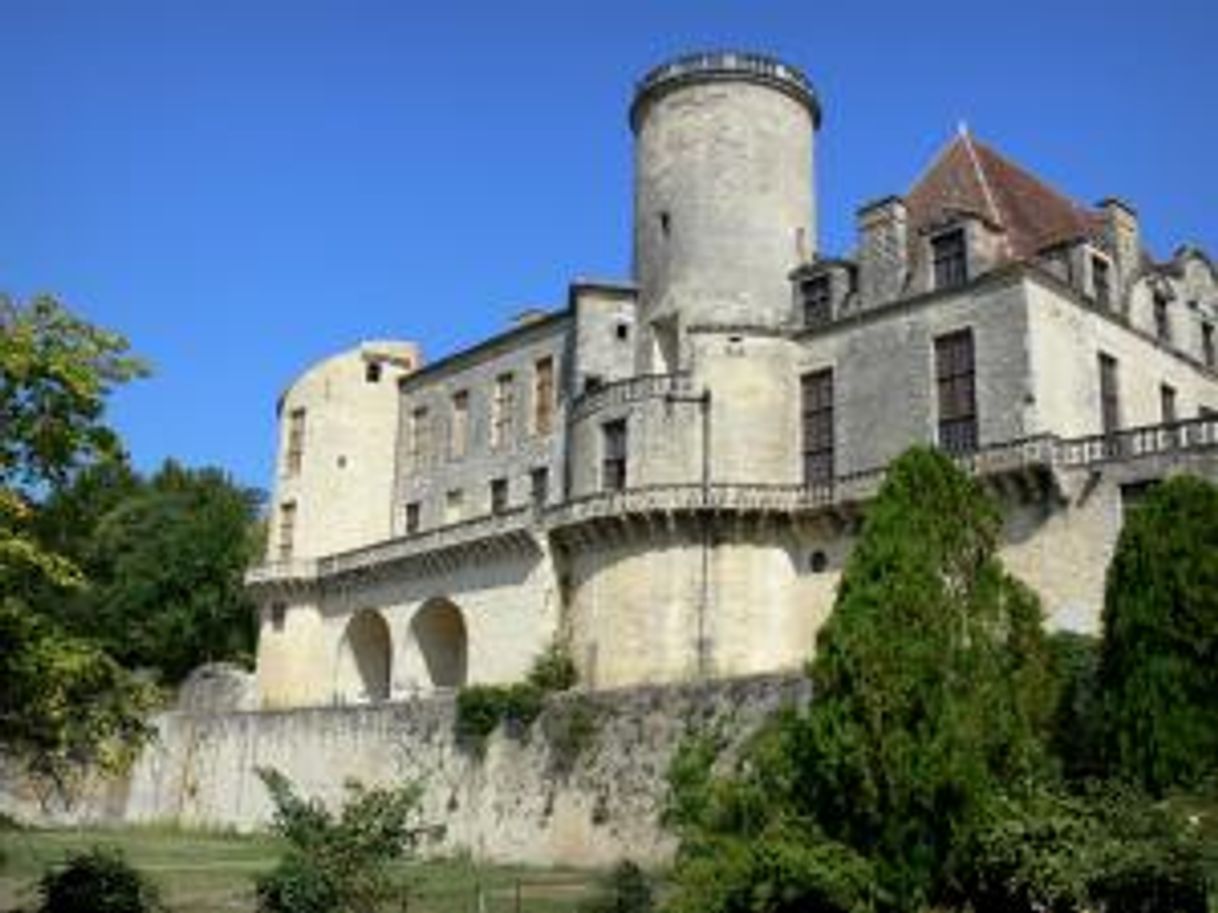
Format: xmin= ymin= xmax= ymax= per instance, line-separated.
xmin=676 ymin=448 xmax=1056 ymax=911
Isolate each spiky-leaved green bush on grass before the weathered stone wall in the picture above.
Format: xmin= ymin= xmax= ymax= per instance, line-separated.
xmin=255 ymin=768 xmax=423 ymax=913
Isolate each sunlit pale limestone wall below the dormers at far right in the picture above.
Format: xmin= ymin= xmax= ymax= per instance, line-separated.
xmin=1027 ymin=278 xmax=1218 ymax=437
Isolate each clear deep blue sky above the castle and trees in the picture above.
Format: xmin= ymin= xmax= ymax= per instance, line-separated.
xmin=0 ymin=0 xmax=1218 ymax=487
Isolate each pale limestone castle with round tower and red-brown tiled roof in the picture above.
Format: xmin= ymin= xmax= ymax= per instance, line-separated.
xmin=248 ymin=52 xmax=1218 ymax=707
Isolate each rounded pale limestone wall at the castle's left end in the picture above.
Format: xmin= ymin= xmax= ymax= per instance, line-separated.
xmin=268 ymin=342 xmax=420 ymax=561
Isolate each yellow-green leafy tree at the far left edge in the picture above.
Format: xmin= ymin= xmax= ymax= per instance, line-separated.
xmin=0 ymin=296 xmax=155 ymax=799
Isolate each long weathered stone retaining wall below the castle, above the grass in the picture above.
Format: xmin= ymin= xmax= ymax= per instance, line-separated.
xmin=9 ymin=676 xmax=809 ymax=866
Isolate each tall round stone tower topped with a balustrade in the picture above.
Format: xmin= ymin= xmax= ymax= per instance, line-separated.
xmin=630 ymin=52 xmax=820 ymax=373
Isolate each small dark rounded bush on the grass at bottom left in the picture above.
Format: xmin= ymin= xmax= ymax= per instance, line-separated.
xmin=39 ymin=846 xmax=164 ymax=913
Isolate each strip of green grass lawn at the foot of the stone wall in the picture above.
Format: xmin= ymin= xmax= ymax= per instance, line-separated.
xmin=0 ymin=828 xmax=597 ymax=913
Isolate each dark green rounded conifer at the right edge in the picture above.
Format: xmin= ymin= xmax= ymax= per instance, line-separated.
xmin=1099 ymin=476 xmax=1218 ymax=794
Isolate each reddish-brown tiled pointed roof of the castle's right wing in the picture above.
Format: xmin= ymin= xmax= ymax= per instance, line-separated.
xmin=905 ymin=130 xmax=1104 ymax=259
